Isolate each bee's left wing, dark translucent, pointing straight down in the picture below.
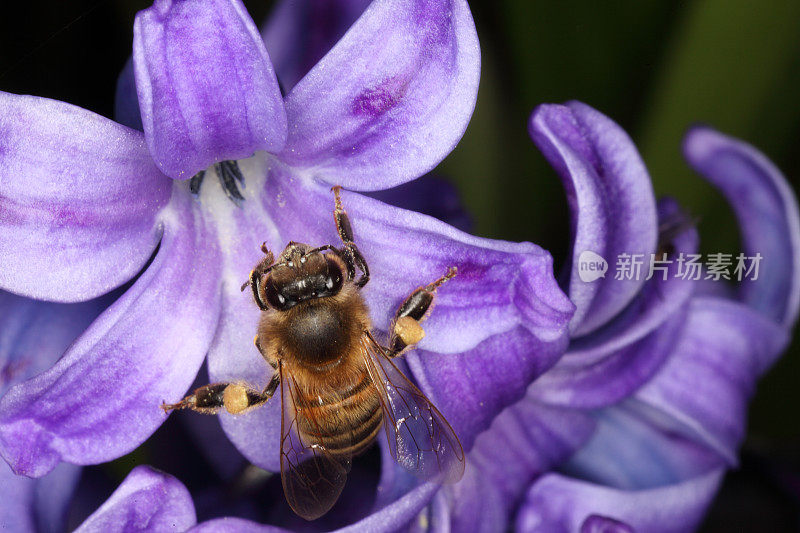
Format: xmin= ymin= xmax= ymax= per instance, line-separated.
xmin=279 ymin=364 xmax=350 ymax=520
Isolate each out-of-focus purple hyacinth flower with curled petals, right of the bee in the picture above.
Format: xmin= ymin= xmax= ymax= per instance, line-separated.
xmin=394 ymin=102 xmax=800 ymax=532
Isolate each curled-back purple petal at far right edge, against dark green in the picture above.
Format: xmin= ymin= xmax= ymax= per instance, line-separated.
xmin=683 ymin=127 xmax=800 ymax=326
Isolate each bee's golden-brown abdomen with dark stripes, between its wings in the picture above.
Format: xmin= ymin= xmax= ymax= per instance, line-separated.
xmin=297 ymin=369 xmax=383 ymax=456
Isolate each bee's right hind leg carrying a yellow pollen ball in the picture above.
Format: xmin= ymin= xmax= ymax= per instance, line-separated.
xmin=388 ymin=267 xmax=458 ymax=357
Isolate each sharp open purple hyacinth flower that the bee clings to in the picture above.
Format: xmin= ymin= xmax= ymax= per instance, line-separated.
xmin=0 ymin=5 xmax=573 ymax=524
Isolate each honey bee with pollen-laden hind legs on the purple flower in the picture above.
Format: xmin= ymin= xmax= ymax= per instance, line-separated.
xmin=162 ymin=187 xmax=464 ymax=520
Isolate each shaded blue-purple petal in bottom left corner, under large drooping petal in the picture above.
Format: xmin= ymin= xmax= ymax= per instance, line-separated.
xmin=0 ymin=461 xmax=81 ymax=533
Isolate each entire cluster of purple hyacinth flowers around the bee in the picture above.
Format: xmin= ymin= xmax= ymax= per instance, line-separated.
xmin=0 ymin=0 xmax=800 ymax=532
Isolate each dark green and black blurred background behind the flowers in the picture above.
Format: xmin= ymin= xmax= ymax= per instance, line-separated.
xmin=0 ymin=0 xmax=800 ymax=531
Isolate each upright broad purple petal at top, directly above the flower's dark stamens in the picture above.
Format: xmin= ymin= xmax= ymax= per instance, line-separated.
xmin=133 ymin=0 xmax=286 ymax=179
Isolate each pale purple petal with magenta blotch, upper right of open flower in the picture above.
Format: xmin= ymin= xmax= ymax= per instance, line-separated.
xmin=280 ymin=0 xmax=480 ymax=190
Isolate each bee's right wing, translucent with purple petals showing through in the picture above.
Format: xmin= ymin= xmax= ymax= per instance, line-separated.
xmin=362 ymin=332 xmax=464 ymax=483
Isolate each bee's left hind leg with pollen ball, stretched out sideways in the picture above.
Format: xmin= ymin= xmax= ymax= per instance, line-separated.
xmin=161 ymin=372 xmax=280 ymax=415
